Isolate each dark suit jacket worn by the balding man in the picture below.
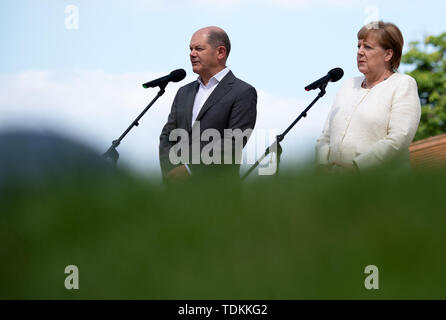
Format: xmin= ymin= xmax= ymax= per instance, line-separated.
xmin=159 ymin=71 xmax=257 ymax=176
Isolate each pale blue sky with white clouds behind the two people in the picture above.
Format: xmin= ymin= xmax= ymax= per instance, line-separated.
xmin=0 ymin=0 xmax=446 ymax=179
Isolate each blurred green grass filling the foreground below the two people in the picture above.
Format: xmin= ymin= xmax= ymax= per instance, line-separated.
xmin=0 ymin=169 xmax=446 ymax=299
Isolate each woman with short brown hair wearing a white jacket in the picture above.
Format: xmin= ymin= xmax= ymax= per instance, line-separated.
xmin=316 ymin=21 xmax=421 ymax=169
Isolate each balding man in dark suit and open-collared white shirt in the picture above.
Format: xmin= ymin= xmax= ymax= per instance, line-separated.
xmin=159 ymin=27 xmax=257 ymax=177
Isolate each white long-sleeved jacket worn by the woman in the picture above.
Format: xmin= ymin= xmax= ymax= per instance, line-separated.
xmin=316 ymin=73 xmax=421 ymax=169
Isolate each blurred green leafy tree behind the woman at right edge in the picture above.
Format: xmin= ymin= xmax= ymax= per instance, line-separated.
xmin=402 ymin=32 xmax=446 ymax=141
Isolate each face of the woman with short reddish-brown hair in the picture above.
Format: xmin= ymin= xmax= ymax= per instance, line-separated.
xmin=357 ymin=33 xmax=393 ymax=76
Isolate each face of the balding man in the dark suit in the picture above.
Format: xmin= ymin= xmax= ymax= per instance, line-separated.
xmin=189 ymin=31 xmax=219 ymax=78
